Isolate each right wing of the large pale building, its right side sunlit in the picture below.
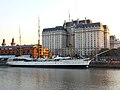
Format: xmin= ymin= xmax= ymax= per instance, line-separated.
xmin=75 ymin=22 xmax=109 ymax=56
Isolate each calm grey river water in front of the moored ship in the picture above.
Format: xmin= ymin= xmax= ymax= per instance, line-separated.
xmin=0 ymin=67 xmax=120 ymax=90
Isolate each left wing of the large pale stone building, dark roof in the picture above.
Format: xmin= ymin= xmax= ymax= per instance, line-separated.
xmin=42 ymin=26 xmax=67 ymax=55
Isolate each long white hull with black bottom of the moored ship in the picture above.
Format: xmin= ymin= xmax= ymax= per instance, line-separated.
xmin=7 ymin=59 xmax=90 ymax=69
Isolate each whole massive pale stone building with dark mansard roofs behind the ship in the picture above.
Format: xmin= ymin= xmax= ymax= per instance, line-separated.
xmin=42 ymin=19 xmax=110 ymax=56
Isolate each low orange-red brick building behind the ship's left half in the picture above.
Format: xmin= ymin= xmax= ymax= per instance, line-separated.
xmin=0 ymin=45 xmax=49 ymax=58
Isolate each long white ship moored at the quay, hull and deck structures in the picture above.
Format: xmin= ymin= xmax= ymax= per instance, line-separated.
xmin=7 ymin=57 xmax=91 ymax=68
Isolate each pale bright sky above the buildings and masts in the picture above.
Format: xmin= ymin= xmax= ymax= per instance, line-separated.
xmin=0 ymin=0 xmax=120 ymax=45
